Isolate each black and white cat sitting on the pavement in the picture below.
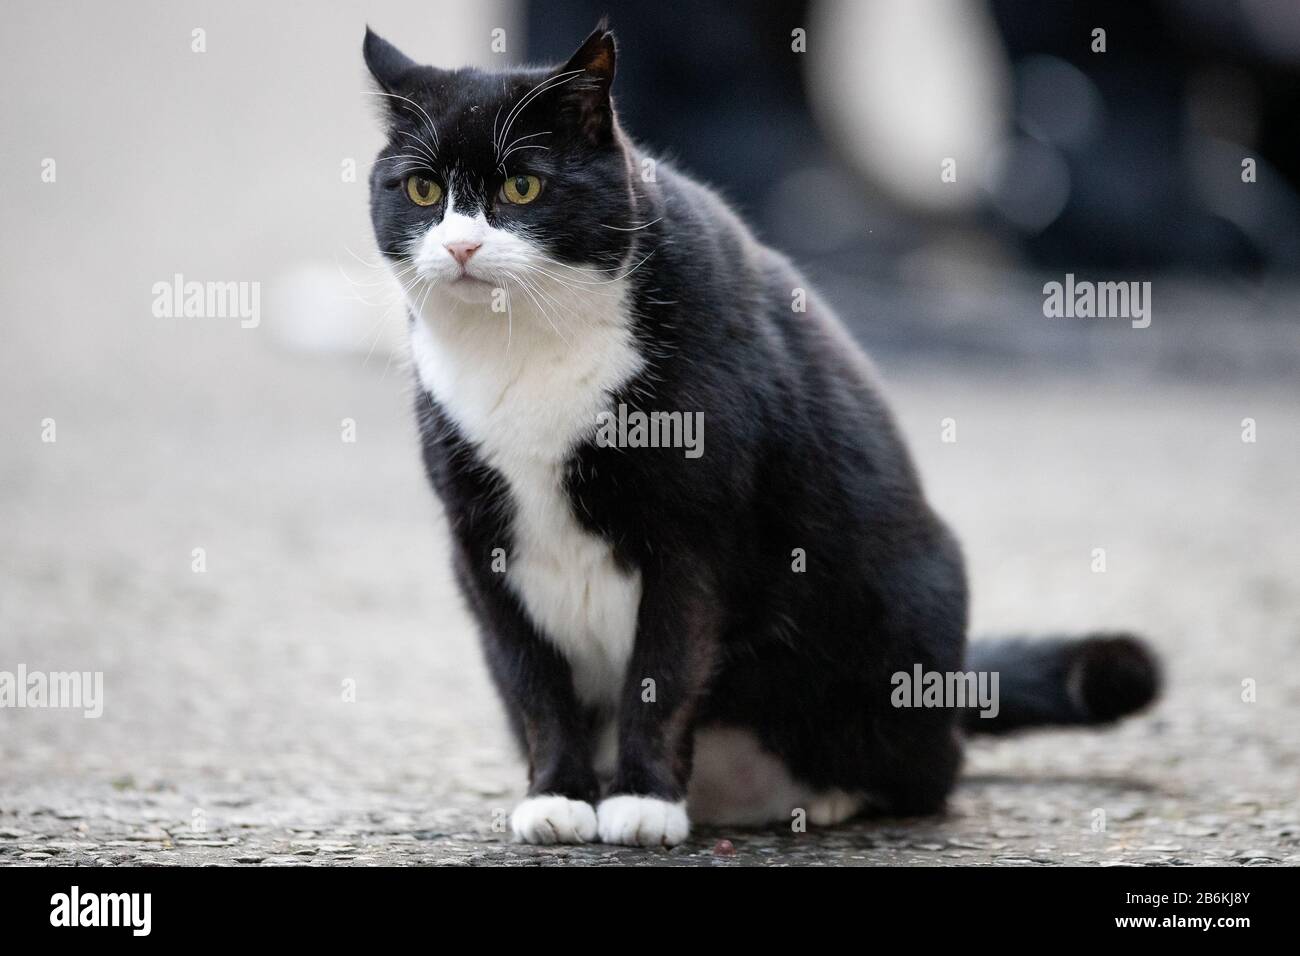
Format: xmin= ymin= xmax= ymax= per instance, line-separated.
xmin=364 ymin=25 xmax=1157 ymax=845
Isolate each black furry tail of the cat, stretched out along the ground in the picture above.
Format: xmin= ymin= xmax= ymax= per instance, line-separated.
xmin=963 ymin=633 xmax=1161 ymax=734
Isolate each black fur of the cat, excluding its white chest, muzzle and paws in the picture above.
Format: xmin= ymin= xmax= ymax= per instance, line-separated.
xmin=365 ymin=29 xmax=1154 ymax=814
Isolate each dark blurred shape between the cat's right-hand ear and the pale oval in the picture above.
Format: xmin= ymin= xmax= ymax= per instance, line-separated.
xmin=528 ymin=0 xmax=920 ymax=310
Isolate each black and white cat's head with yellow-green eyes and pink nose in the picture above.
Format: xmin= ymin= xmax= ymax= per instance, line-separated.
xmin=364 ymin=23 xmax=634 ymax=303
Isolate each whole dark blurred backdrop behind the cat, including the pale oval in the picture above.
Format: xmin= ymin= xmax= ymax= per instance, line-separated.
xmin=528 ymin=0 xmax=1300 ymax=390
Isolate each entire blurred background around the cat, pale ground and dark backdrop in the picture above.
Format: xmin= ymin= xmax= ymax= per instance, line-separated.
xmin=0 ymin=0 xmax=1300 ymax=861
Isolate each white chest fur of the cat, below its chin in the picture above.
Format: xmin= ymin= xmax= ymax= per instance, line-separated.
xmin=411 ymin=273 xmax=644 ymax=705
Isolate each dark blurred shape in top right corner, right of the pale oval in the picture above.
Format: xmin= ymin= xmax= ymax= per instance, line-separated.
xmin=991 ymin=0 xmax=1300 ymax=273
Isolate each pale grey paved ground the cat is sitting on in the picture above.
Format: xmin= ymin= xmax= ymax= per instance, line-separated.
xmin=0 ymin=328 xmax=1300 ymax=865
